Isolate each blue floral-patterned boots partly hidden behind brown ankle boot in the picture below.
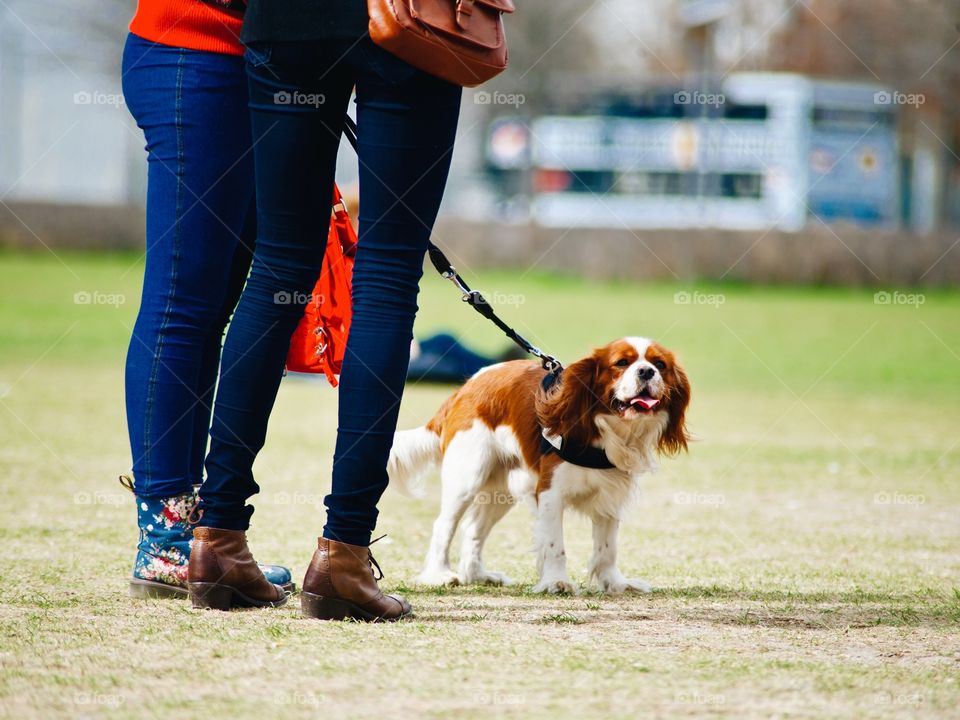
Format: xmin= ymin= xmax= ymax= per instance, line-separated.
xmin=120 ymin=475 xmax=295 ymax=598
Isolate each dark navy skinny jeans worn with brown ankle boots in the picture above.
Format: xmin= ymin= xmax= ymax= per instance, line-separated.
xmin=201 ymin=38 xmax=461 ymax=545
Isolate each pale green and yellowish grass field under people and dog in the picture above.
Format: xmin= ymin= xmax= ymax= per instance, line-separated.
xmin=0 ymin=249 xmax=960 ymax=718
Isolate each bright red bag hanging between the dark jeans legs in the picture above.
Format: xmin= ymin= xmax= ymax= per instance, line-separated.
xmin=287 ymin=184 xmax=357 ymax=387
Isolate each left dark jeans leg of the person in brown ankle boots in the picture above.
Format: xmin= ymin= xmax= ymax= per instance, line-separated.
xmin=201 ymin=43 xmax=353 ymax=531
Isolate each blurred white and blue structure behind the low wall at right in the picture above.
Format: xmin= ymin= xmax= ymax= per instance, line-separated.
xmin=485 ymin=73 xmax=900 ymax=231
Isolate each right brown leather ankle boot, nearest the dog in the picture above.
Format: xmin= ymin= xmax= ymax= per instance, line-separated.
xmin=300 ymin=538 xmax=413 ymax=622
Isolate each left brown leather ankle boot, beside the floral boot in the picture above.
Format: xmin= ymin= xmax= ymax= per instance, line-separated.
xmin=187 ymin=527 xmax=287 ymax=610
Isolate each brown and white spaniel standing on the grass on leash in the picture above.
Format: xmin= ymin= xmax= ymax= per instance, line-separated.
xmin=388 ymin=337 xmax=690 ymax=593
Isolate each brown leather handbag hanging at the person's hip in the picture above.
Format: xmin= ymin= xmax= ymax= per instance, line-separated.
xmin=367 ymin=0 xmax=516 ymax=87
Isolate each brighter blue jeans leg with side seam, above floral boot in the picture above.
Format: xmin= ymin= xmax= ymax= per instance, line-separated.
xmin=122 ymin=34 xmax=256 ymax=498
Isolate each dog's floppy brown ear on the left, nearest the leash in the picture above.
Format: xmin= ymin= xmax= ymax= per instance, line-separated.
xmin=537 ymin=353 xmax=602 ymax=445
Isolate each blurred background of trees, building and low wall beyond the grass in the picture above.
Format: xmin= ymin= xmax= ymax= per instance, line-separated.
xmin=0 ymin=0 xmax=960 ymax=285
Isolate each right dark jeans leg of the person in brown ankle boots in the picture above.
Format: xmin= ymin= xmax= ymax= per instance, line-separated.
xmin=323 ymin=41 xmax=461 ymax=546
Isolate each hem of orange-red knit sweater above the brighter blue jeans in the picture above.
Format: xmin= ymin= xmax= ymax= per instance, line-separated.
xmin=130 ymin=0 xmax=243 ymax=55
